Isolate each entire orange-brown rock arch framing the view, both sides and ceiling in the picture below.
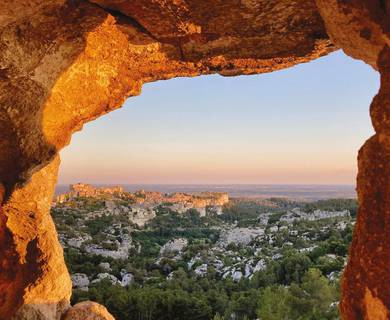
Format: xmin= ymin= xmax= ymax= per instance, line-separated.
xmin=0 ymin=0 xmax=390 ymax=319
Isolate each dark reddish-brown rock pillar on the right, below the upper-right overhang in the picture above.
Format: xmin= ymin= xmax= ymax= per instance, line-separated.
xmin=341 ymin=47 xmax=390 ymax=320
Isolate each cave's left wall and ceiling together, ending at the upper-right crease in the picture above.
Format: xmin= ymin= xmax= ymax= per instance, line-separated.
xmin=0 ymin=0 xmax=334 ymax=319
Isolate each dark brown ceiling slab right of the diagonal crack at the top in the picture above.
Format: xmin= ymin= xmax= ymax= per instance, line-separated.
xmin=91 ymin=0 xmax=329 ymax=68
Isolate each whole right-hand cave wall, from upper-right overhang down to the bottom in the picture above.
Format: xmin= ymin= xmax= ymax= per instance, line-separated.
xmin=317 ymin=0 xmax=390 ymax=320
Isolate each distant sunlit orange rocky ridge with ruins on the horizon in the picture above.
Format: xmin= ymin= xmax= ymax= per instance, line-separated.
xmin=53 ymin=183 xmax=229 ymax=227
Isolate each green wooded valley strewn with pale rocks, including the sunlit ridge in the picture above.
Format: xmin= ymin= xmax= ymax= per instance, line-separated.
xmin=52 ymin=184 xmax=357 ymax=320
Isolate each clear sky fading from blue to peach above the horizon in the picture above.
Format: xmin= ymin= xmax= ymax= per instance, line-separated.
xmin=59 ymin=51 xmax=379 ymax=184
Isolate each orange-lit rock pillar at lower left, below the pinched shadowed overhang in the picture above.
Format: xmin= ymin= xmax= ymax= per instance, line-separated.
xmin=0 ymin=157 xmax=71 ymax=319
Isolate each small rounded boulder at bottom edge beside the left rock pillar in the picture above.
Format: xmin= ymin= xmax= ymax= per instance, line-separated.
xmin=63 ymin=301 xmax=115 ymax=320
